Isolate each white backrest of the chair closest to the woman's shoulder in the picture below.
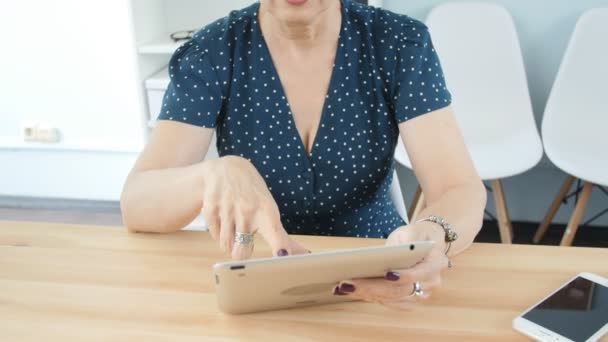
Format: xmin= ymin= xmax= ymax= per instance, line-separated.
xmin=426 ymin=2 xmax=538 ymax=145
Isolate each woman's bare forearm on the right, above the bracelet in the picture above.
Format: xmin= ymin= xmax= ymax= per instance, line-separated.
xmin=411 ymin=182 xmax=487 ymax=255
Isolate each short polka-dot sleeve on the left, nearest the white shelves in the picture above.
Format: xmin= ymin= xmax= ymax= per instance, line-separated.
xmin=158 ymin=40 xmax=223 ymax=128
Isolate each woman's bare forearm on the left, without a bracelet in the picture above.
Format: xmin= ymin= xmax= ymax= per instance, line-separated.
xmin=120 ymin=161 xmax=208 ymax=233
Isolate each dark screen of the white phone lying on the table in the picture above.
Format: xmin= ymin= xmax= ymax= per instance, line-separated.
xmin=523 ymin=277 xmax=608 ymax=341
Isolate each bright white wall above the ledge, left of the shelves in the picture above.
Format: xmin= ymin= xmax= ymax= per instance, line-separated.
xmin=0 ymin=0 xmax=143 ymax=150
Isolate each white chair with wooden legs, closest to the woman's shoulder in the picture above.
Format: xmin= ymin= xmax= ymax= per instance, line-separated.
xmin=396 ymin=2 xmax=542 ymax=243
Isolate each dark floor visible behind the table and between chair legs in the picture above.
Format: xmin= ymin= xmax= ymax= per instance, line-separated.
xmin=0 ymin=207 xmax=608 ymax=247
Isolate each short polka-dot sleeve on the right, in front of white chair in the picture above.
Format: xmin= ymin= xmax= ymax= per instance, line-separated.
xmin=393 ymin=22 xmax=452 ymax=123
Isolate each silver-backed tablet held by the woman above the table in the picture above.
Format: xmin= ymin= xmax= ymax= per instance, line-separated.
xmin=213 ymin=241 xmax=434 ymax=314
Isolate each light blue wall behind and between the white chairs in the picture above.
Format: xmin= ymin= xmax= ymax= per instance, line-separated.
xmin=383 ymin=0 xmax=608 ymax=226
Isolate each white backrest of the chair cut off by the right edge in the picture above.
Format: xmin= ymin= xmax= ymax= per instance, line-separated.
xmin=542 ymin=8 xmax=608 ymax=162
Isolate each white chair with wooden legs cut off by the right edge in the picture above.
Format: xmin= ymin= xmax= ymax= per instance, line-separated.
xmin=534 ymin=8 xmax=608 ymax=246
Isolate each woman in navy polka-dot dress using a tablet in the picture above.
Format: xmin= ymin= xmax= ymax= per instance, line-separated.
xmin=121 ymin=0 xmax=486 ymax=303
